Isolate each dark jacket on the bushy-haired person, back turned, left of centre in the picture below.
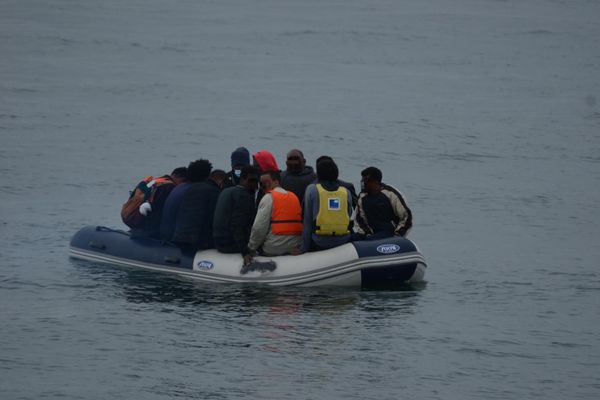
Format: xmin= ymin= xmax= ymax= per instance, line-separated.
xmin=173 ymin=179 xmax=220 ymax=249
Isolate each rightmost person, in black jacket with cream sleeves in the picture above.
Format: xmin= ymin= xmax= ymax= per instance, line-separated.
xmin=356 ymin=167 xmax=412 ymax=240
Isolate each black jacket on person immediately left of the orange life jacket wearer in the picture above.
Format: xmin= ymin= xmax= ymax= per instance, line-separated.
xmin=213 ymin=186 xmax=256 ymax=255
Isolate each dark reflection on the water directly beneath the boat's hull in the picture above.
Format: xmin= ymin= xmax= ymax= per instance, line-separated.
xmin=72 ymin=260 xmax=426 ymax=315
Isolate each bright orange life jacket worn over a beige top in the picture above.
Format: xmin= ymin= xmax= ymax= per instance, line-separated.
xmin=270 ymin=190 xmax=303 ymax=235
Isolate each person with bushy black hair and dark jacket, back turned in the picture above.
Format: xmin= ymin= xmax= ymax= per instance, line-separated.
xmin=171 ymin=159 xmax=225 ymax=251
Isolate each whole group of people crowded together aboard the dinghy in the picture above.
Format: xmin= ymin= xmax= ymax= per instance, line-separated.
xmin=122 ymin=147 xmax=412 ymax=263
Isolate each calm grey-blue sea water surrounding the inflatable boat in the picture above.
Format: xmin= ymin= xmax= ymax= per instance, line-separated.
xmin=0 ymin=0 xmax=600 ymax=399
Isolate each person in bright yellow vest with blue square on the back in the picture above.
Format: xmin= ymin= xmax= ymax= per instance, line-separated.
xmin=302 ymin=159 xmax=353 ymax=252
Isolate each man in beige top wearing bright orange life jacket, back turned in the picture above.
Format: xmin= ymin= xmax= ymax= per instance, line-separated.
xmin=244 ymin=171 xmax=303 ymax=264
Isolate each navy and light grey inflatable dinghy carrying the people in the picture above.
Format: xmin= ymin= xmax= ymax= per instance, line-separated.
xmin=70 ymin=226 xmax=426 ymax=288
